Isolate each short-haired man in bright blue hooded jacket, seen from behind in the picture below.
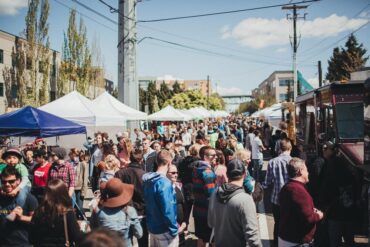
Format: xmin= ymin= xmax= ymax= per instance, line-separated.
xmin=143 ymin=150 xmax=179 ymax=247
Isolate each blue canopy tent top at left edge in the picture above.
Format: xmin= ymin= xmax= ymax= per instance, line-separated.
xmin=0 ymin=106 xmax=86 ymax=137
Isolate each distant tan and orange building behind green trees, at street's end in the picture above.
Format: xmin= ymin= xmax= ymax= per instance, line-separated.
xmin=139 ymin=77 xmax=212 ymax=96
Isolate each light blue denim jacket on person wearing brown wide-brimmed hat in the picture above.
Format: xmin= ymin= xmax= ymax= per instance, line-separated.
xmin=91 ymin=206 xmax=143 ymax=247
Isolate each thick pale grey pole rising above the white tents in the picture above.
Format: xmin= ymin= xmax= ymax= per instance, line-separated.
xmin=117 ymin=0 xmax=139 ymax=110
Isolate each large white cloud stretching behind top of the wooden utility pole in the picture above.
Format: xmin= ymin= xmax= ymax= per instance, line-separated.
xmin=221 ymin=14 xmax=368 ymax=48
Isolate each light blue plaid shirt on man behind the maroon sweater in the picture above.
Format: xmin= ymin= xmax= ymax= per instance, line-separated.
xmin=263 ymin=153 xmax=292 ymax=205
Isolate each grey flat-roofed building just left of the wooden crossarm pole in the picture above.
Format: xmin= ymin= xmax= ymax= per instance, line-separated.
xmin=252 ymin=70 xmax=294 ymax=102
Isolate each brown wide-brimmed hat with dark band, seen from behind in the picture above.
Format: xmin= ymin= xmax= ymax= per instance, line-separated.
xmin=102 ymin=178 xmax=134 ymax=208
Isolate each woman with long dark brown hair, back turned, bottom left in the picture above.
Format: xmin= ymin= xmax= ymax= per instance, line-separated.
xmin=30 ymin=179 xmax=83 ymax=247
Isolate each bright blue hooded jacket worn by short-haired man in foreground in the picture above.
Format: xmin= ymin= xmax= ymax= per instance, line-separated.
xmin=143 ymin=172 xmax=177 ymax=237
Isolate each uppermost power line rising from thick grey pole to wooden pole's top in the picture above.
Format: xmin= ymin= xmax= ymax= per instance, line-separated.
xmin=137 ymin=0 xmax=321 ymax=23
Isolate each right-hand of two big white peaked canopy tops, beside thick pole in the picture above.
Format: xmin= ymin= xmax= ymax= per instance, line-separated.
xmin=92 ymin=92 xmax=148 ymax=120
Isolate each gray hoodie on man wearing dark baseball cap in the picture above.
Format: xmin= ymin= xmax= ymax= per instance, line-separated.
xmin=208 ymin=183 xmax=262 ymax=247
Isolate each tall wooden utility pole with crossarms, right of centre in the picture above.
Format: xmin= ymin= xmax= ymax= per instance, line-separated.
xmin=282 ymin=4 xmax=308 ymax=101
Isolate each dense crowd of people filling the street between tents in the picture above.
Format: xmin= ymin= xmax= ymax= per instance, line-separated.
xmin=0 ymin=116 xmax=353 ymax=247
